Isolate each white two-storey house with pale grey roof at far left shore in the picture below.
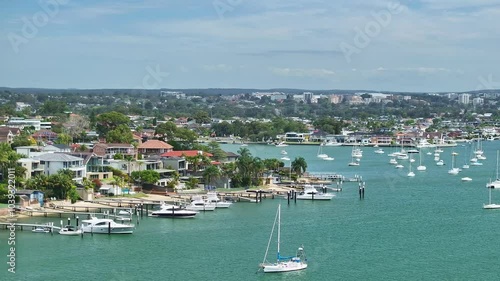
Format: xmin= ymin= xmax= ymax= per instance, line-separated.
xmin=33 ymin=153 xmax=87 ymax=183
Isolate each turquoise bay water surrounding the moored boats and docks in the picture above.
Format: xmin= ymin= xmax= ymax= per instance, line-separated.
xmin=0 ymin=141 xmax=500 ymax=280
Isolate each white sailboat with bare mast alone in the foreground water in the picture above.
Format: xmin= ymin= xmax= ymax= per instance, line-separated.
xmin=260 ymin=204 xmax=307 ymax=273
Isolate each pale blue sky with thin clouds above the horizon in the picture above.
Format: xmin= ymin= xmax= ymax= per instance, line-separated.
xmin=0 ymin=0 xmax=500 ymax=92
